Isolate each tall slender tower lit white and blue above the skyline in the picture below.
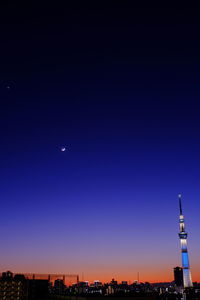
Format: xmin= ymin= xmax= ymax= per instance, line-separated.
xmin=178 ymin=194 xmax=193 ymax=288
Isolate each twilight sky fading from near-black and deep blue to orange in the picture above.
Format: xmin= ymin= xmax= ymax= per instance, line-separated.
xmin=0 ymin=1 xmax=200 ymax=282
